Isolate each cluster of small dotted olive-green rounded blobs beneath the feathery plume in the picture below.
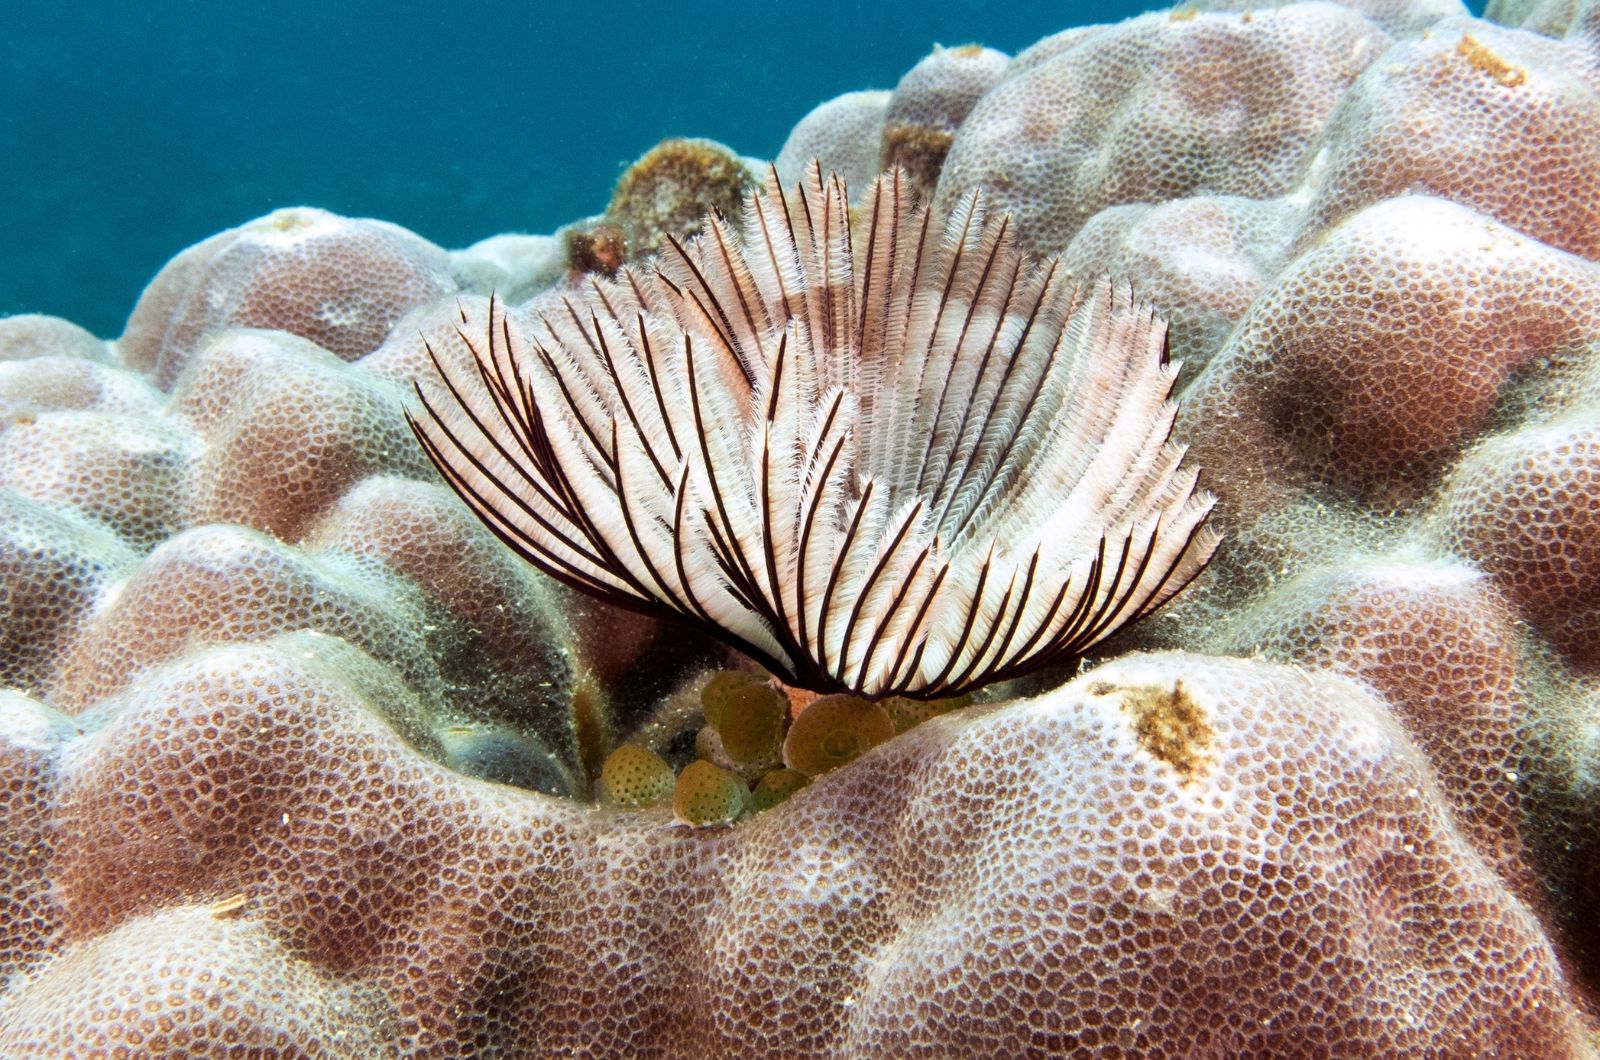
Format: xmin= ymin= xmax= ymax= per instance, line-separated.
xmin=600 ymin=669 xmax=971 ymax=826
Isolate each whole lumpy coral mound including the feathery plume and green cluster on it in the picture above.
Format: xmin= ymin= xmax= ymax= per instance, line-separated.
xmin=0 ymin=0 xmax=1600 ymax=1060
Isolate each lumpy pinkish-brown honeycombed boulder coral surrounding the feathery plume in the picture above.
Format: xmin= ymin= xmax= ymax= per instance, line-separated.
xmin=9 ymin=0 xmax=1600 ymax=1058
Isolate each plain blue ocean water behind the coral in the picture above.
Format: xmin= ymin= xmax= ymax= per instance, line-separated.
xmin=0 ymin=0 xmax=1164 ymax=336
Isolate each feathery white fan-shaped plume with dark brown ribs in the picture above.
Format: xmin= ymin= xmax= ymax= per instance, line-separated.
xmin=413 ymin=168 xmax=1216 ymax=697
